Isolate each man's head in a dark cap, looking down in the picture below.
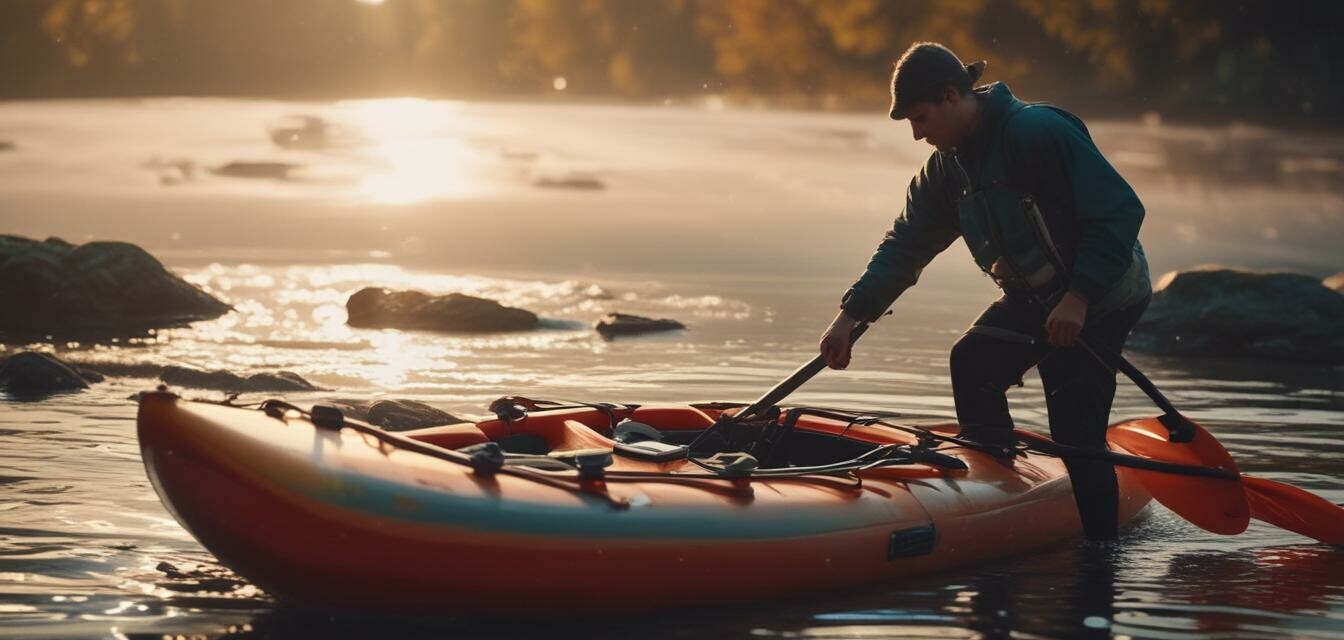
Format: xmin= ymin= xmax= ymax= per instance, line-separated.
xmin=891 ymin=42 xmax=985 ymax=151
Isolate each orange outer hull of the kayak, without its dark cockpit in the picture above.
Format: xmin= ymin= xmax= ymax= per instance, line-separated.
xmin=137 ymin=393 xmax=1149 ymax=614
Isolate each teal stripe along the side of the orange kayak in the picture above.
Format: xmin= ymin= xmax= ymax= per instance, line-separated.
xmin=279 ymin=471 xmax=890 ymax=539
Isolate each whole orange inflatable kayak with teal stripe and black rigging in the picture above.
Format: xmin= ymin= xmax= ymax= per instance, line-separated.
xmin=137 ymin=390 xmax=1150 ymax=616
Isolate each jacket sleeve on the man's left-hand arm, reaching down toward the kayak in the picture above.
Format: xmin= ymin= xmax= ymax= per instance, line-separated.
xmin=840 ymin=153 xmax=961 ymax=323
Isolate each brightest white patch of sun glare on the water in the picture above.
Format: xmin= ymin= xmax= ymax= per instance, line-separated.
xmin=351 ymin=98 xmax=478 ymax=204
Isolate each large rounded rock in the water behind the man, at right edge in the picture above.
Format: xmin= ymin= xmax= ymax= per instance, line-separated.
xmin=1129 ymin=268 xmax=1344 ymax=363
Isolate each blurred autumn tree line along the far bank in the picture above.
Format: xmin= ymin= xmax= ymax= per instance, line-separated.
xmin=0 ymin=0 xmax=1344 ymax=125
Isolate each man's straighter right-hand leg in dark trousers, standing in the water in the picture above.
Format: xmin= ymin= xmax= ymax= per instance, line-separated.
xmin=1038 ymin=300 xmax=1148 ymax=541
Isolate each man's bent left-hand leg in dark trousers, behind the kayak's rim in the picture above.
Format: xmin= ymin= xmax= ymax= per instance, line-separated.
xmin=950 ymin=298 xmax=1047 ymax=444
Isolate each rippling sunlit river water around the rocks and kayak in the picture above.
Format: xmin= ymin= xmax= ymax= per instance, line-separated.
xmin=0 ymin=99 xmax=1344 ymax=639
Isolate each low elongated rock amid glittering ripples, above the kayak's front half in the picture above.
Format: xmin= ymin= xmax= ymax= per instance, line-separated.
xmin=345 ymin=288 xmax=538 ymax=332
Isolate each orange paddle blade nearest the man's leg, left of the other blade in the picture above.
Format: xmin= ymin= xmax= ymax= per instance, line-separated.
xmin=1106 ymin=418 xmax=1250 ymax=535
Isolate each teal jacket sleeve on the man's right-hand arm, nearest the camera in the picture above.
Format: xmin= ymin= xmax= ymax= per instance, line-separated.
xmin=1009 ymin=108 xmax=1144 ymax=303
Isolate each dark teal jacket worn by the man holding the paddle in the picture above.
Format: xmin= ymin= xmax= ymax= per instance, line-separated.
xmin=841 ymin=82 xmax=1150 ymax=321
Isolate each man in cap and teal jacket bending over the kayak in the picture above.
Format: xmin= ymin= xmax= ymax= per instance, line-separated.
xmin=820 ymin=43 xmax=1152 ymax=539
